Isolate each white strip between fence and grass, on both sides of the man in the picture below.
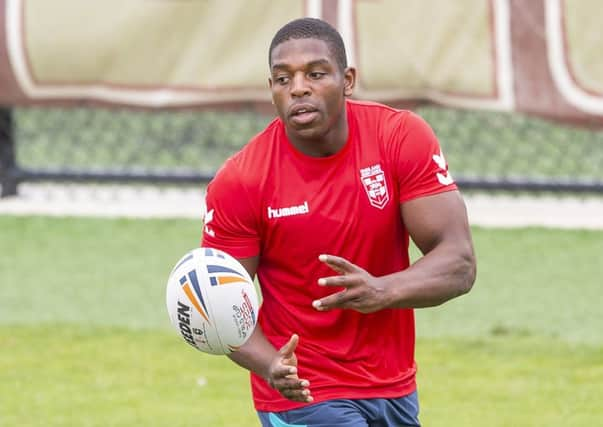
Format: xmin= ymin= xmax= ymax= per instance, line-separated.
xmin=0 ymin=183 xmax=603 ymax=229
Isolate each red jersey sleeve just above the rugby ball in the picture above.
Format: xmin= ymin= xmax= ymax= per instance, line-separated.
xmin=201 ymin=159 xmax=260 ymax=258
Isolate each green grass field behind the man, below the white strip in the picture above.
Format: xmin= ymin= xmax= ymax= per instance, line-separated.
xmin=0 ymin=216 xmax=603 ymax=427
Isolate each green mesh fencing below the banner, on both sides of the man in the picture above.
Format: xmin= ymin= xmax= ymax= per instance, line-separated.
xmin=0 ymin=107 xmax=603 ymax=192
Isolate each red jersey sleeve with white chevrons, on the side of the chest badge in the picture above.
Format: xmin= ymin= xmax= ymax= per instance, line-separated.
xmin=392 ymin=112 xmax=457 ymax=203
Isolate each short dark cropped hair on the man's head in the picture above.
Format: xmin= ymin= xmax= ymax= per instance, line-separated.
xmin=268 ymin=18 xmax=348 ymax=71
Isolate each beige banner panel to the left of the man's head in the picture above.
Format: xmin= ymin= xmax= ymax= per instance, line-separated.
xmin=24 ymin=0 xmax=303 ymax=88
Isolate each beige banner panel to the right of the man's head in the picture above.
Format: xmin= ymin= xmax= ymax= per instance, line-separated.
xmin=356 ymin=0 xmax=495 ymax=95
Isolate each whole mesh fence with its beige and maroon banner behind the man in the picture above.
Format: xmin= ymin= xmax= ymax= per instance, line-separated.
xmin=0 ymin=0 xmax=603 ymax=203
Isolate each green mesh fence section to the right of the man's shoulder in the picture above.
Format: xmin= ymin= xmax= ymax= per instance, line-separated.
xmin=418 ymin=108 xmax=603 ymax=183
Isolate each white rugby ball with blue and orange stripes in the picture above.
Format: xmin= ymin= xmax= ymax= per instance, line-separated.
xmin=166 ymin=247 xmax=259 ymax=354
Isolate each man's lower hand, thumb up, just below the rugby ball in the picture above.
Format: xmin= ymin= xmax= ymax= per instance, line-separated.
xmin=267 ymin=334 xmax=314 ymax=403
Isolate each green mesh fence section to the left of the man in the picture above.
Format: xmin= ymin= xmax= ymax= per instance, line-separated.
xmin=14 ymin=108 xmax=270 ymax=174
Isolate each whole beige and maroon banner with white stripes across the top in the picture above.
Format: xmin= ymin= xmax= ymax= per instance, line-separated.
xmin=0 ymin=0 xmax=603 ymax=119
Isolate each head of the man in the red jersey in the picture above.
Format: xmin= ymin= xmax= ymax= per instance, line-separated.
xmin=268 ymin=18 xmax=356 ymax=156
